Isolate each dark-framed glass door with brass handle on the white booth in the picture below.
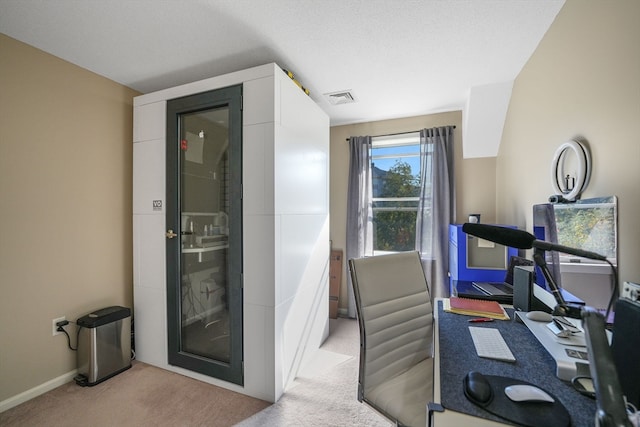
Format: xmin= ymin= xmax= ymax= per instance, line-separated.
xmin=166 ymin=86 xmax=243 ymax=385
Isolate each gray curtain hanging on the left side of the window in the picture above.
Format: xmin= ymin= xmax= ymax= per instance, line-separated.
xmin=346 ymin=136 xmax=373 ymax=318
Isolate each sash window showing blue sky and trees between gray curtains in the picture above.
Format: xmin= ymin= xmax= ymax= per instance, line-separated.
xmin=371 ymin=132 xmax=420 ymax=254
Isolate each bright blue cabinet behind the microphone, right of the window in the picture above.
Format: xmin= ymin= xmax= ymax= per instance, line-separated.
xmin=449 ymin=224 xmax=518 ymax=290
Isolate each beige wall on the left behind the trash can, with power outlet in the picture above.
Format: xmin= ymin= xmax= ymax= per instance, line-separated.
xmin=0 ymin=34 xmax=137 ymax=402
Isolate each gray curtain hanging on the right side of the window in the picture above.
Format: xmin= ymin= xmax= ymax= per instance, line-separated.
xmin=416 ymin=126 xmax=456 ymax=298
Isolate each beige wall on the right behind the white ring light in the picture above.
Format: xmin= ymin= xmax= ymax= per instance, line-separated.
xmin=497 ymin=0 xmax=640 ymax=288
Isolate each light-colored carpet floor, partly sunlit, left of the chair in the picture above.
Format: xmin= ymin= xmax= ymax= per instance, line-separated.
xmin=0 ymin=319 xmax=392 ymax=427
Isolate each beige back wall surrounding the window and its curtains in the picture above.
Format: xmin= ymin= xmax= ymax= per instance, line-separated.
xmin=330 ymin=111 xmax=496 ymax=312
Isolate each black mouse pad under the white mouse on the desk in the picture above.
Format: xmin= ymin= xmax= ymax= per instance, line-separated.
xmin=463 ymin=375 xmax=571 ymax=427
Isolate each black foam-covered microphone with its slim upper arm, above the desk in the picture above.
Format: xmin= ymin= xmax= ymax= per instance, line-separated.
xmin=462 ymin=223 xmax=607 ymax=261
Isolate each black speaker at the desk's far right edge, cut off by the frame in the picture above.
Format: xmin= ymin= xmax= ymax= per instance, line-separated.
xmin=611 ymin=298 xmax=640 ymax=408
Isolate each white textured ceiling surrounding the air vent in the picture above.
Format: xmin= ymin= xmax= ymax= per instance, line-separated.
xmin=0 ymin=0 xmax=564 ymax=125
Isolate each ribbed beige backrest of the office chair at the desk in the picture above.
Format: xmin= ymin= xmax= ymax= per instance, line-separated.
xmin=349 ymin=252 xmax=433 ymax=397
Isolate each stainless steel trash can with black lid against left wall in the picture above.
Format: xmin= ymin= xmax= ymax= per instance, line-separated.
xmin=75 ymin=306 xmax=131 ymax=386
